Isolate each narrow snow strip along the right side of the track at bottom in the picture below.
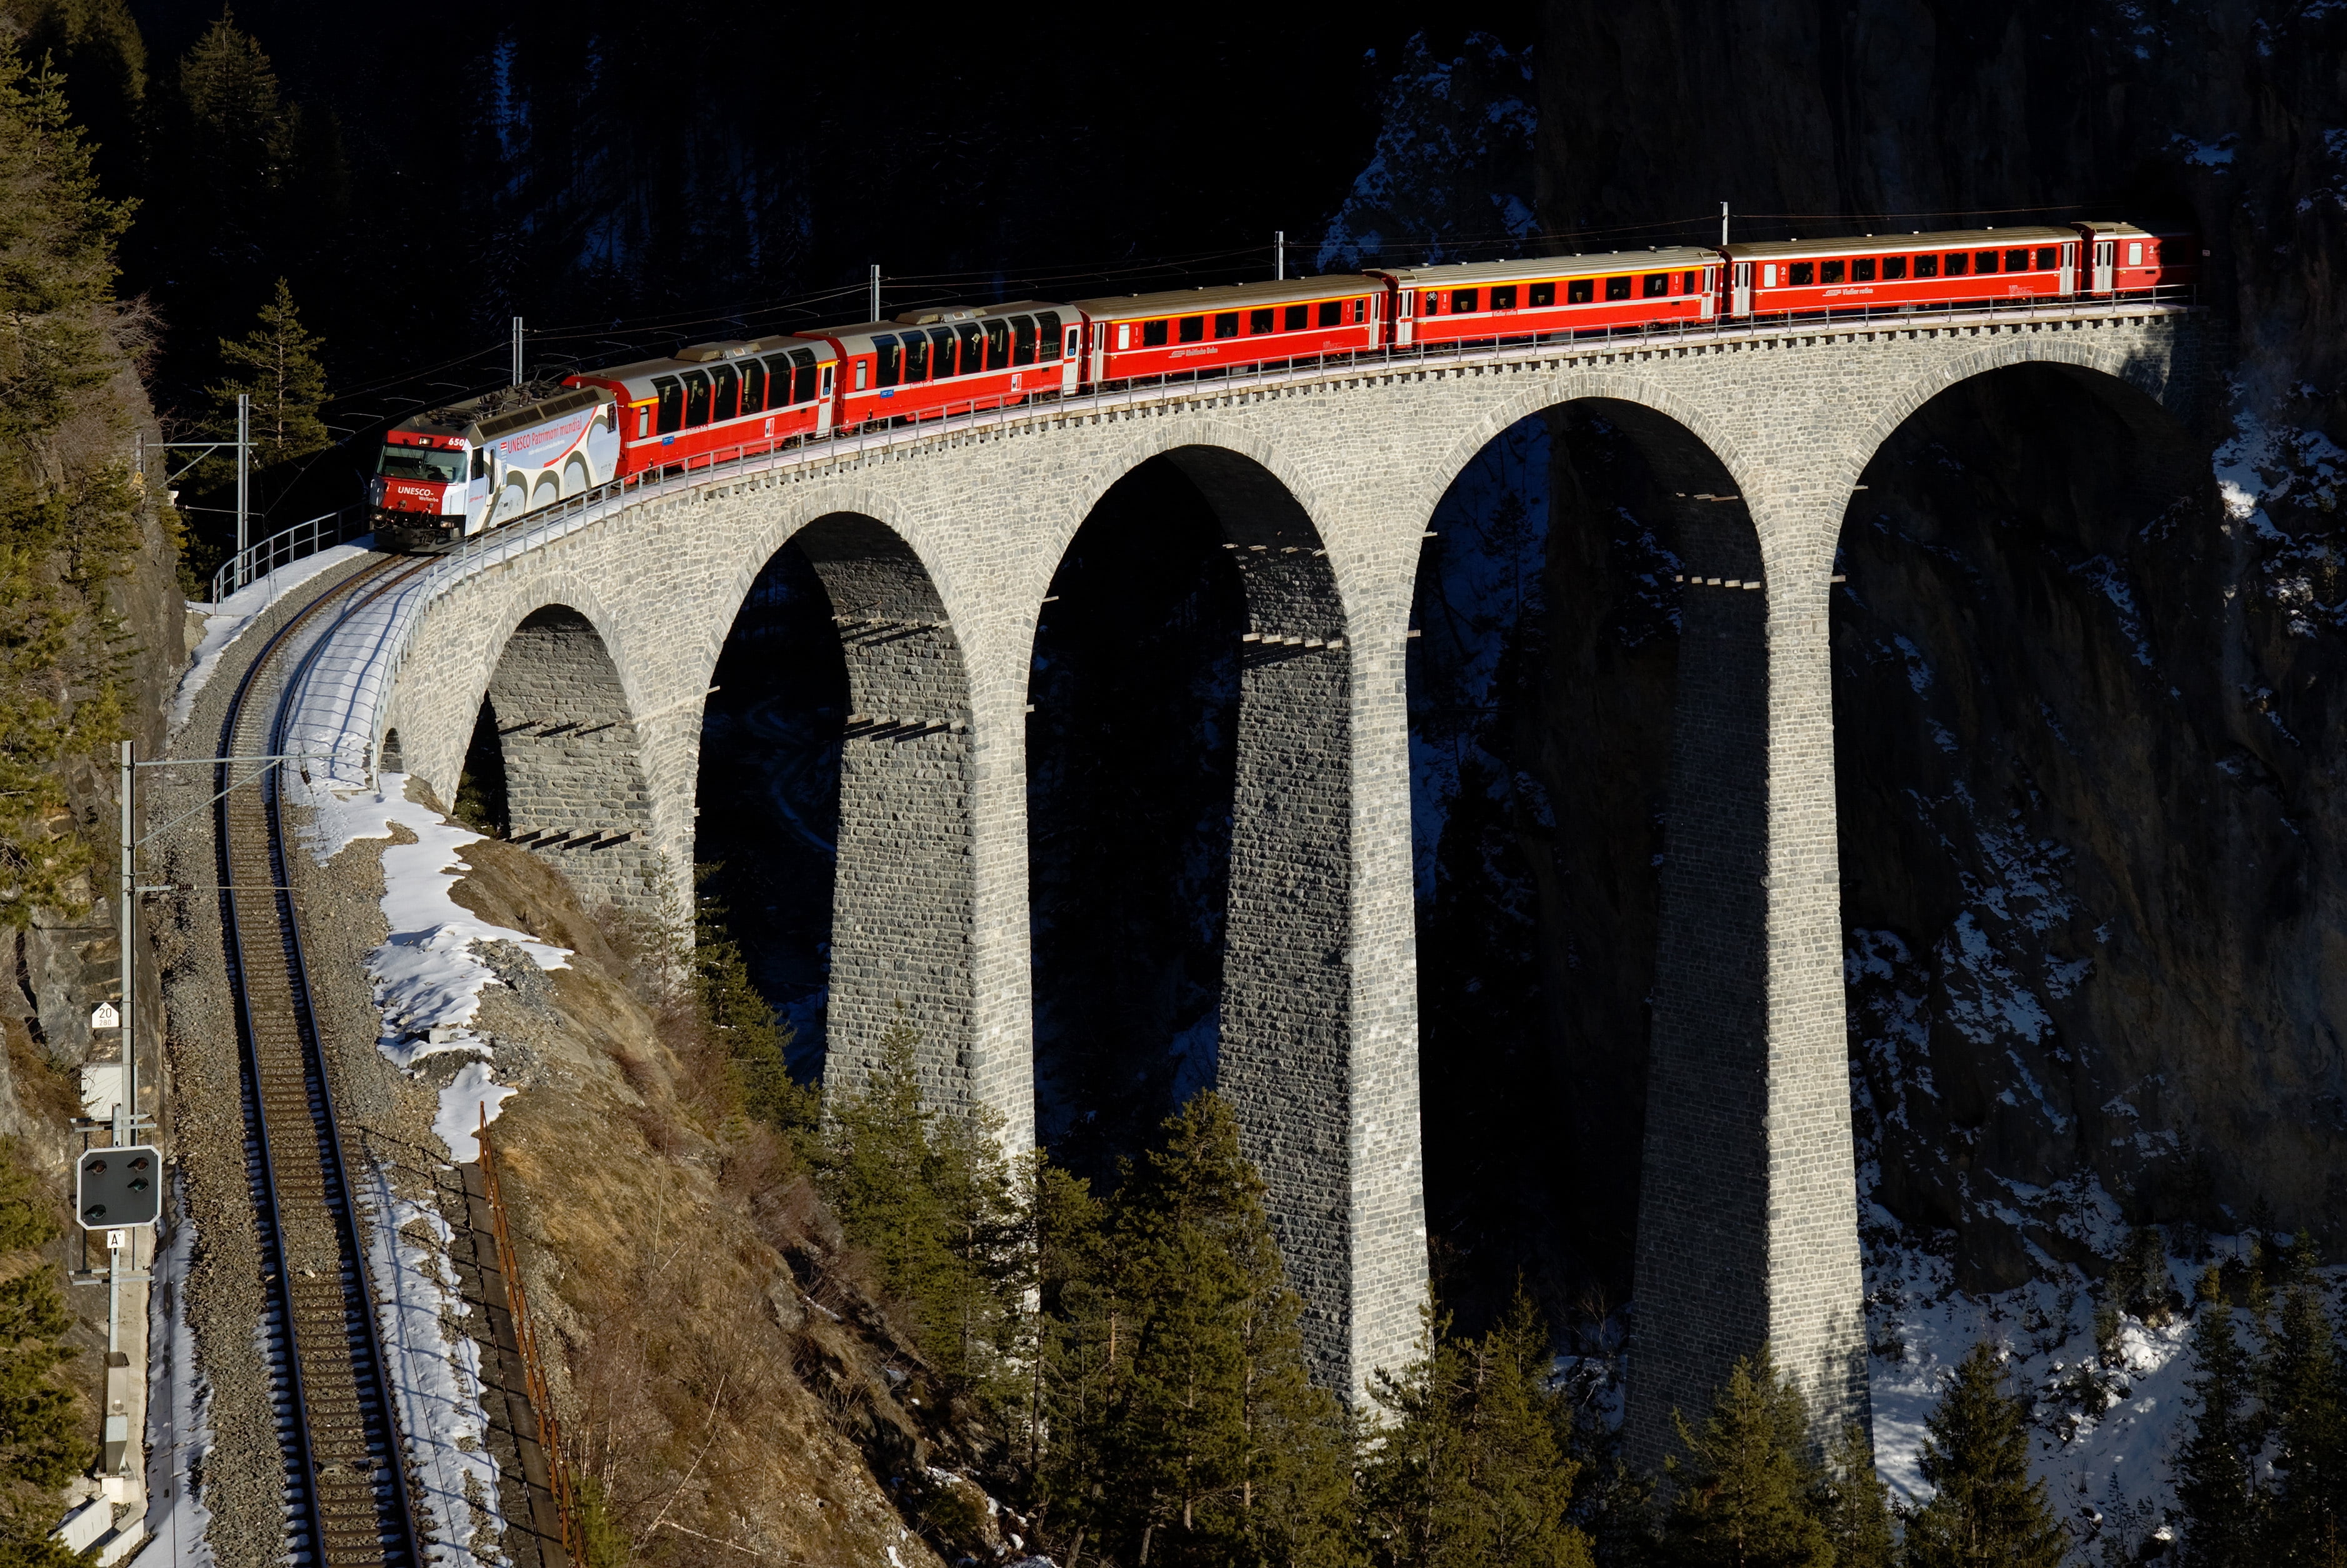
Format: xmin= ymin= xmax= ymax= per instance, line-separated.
xmin=361 ymin=1164 xmax=504 ymax=1568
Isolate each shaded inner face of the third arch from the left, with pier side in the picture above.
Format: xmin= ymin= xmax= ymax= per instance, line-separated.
xmin=1033 ymin=439 xmax=1370 ymax=1390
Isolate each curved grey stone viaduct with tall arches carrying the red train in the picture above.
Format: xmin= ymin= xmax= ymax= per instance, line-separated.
xmin=296 ymin=305 xmax=2206 ymax=1457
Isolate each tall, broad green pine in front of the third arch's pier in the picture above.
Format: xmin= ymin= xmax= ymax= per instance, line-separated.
xmin=1056 ymin=1092 xmax=1359 ymax=1568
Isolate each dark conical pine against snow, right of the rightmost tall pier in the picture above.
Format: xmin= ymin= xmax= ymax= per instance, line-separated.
xmin=1906 ymin=1342 xmax=2070 ymax=1568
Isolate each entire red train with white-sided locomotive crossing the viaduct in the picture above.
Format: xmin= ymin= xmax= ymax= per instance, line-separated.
xmin=369 ymin=223 xmax=2204 ymax=549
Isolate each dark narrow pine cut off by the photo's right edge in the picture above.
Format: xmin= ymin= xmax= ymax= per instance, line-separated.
xmin=2263 ymin=1232 xmax=2347 ymax=1568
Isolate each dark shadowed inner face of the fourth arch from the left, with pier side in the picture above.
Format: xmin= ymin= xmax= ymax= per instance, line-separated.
xmin=1423 ymin=384 xmax=1838 ymax=1462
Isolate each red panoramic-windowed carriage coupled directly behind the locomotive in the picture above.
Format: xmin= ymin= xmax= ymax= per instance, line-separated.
xmin=566 ymin=338 xmax=838 ymax=479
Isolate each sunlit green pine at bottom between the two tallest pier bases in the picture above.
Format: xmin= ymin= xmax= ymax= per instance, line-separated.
xmin=1364 ymin=1286 xmax=1594 ymax=1568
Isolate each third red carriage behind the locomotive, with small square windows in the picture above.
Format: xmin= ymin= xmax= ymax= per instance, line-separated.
xmin=1075 ymin=272 xmax=1387 ymax=382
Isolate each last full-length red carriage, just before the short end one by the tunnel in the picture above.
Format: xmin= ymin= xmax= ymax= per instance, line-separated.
xmin=1728 ymin=227 xmax=2079 ymax=317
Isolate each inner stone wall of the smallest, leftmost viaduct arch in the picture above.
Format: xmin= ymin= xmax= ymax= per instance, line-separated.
xmin=484 ymin=603 xmax=676 ymax=909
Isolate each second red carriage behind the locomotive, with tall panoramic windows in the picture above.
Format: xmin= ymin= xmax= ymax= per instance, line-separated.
xmin=800 ymin=301 xmax=1084 ymax=429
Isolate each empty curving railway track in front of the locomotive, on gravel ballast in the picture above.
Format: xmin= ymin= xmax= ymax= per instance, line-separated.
xmin=214 ymin=559 xmax=427 ymax=1568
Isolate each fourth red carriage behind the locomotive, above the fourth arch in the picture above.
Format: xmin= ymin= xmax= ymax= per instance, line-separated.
xmin=1371 ymin=246 xmax=1720 ymax=342
